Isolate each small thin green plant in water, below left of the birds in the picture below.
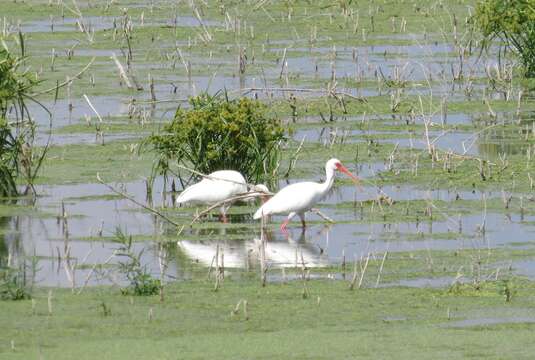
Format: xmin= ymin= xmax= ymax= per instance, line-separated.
xmin=114 ymin=229 xmax=161 ymax=296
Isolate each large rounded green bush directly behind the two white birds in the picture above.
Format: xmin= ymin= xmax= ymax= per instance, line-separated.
xmin=148 ymin=94 xmax=284 ymax=186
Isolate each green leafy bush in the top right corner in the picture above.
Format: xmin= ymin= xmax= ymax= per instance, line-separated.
xmin=475 ymin=0 xmax=535 ymax=77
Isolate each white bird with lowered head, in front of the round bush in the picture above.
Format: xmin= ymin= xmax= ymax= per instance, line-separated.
xmin=176 ymin=170 xmax=269 ymax=222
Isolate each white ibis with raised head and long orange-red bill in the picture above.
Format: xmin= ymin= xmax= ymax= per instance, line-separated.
xmin=254 ymin=159 xmax=359 ymax=232
